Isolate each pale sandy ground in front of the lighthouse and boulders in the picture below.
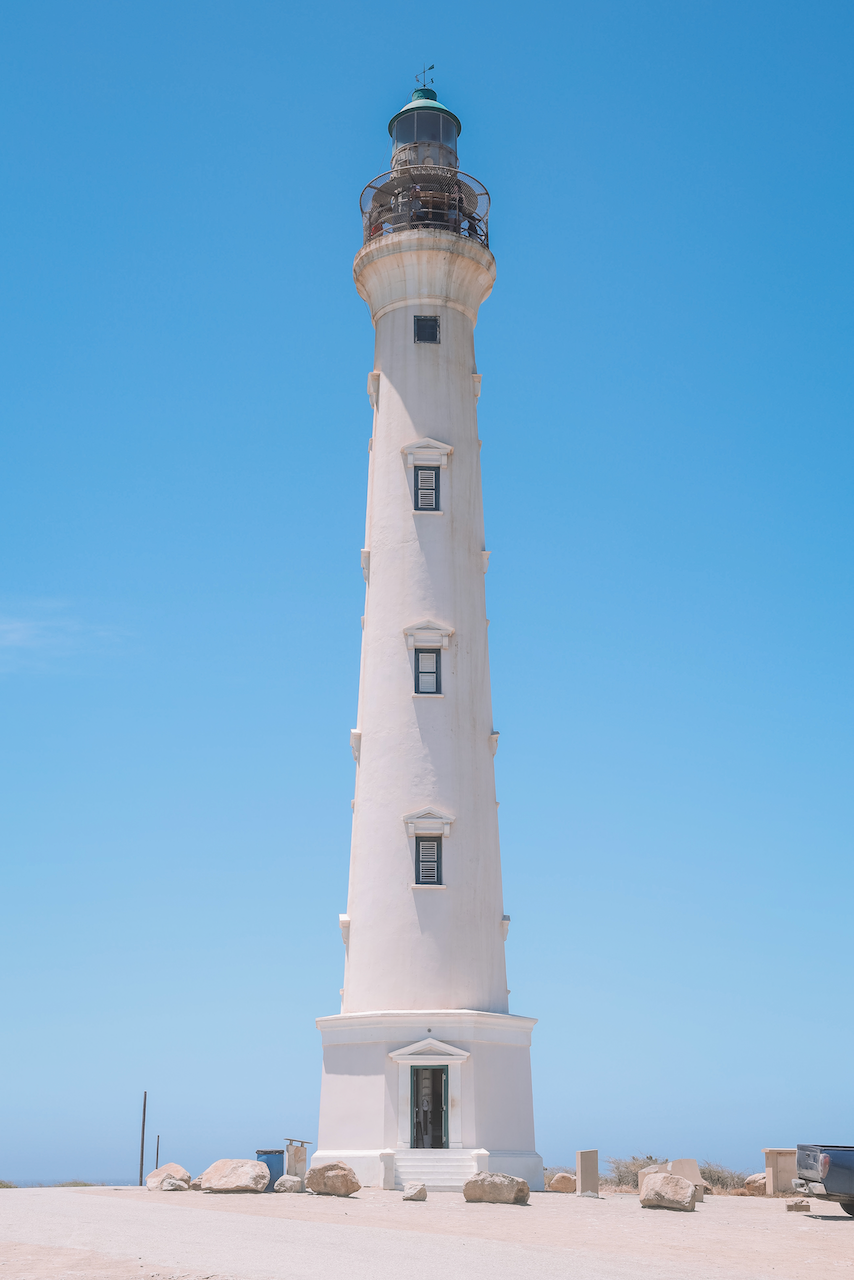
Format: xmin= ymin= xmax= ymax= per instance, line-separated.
xmin=0 ymin=1187 xmax=854 ymax=1280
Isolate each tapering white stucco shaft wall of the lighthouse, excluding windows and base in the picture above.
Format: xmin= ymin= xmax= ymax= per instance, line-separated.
xmin=342 ymin=230 xmax=507 ymax=1012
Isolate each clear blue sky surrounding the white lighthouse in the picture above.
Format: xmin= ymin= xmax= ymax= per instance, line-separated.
xmin=0 ymin=0 xmax=854 ymax=1181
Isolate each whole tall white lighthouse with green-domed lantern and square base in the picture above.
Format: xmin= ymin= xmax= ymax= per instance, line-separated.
xmin=312 ymin=87 xmax=543 ymax=1189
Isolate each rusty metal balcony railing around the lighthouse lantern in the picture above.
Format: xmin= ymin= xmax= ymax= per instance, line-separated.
xmin=361 ymin=165 xmax=489 ymax=247
